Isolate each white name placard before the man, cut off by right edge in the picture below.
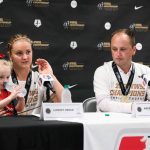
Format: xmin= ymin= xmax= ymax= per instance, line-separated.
xmin=132 ymin=102 xmax=150 ymax=117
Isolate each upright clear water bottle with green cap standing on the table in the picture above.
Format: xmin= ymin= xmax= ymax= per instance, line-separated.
xmin=61 ymin=85 xmax=72 ymax=103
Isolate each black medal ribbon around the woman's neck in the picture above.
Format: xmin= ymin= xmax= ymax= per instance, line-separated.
xmin=11 ymin=70 xmax=32 ymax=103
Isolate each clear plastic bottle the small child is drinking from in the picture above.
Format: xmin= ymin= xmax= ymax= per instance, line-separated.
xmin=4 ymin=82 xmax=27 ymax=97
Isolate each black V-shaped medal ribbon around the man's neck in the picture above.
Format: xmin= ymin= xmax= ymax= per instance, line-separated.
xmin=112 ymin=62 xmax=135 ymax=95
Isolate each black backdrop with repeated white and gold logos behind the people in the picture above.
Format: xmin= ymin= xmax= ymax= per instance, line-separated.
xmin=0 ymin=0 xmax=150 ymax=102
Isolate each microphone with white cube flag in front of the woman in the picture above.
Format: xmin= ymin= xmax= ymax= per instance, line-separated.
xmin=38 ymin=74 xmax=55 ymax=93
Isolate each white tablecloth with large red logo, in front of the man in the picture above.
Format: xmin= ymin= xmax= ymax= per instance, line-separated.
xmin=55 ymin=113 xmax=150 ymax=150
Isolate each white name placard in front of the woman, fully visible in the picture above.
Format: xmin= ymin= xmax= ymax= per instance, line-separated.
xmin=40 ymin=103 xmax=83 ymax=120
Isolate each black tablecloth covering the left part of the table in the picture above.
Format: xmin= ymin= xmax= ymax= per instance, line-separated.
xmin=0 ymin=116 xmax=83 ymax=150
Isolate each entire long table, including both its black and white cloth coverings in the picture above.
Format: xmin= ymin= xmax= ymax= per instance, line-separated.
xmin=0 ymin=113 xmax=150 ymax=150
